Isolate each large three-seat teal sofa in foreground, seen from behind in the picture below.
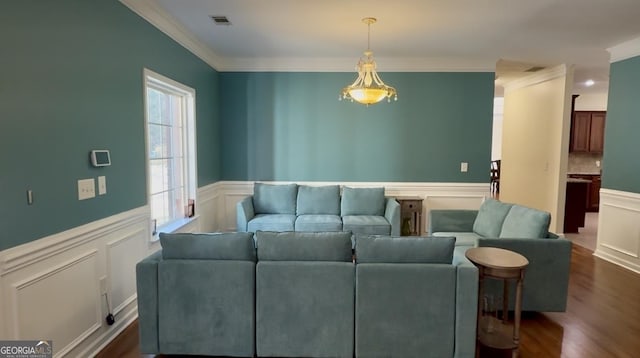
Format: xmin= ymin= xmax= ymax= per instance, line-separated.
xmin=136 ymin=231 xmax=478 ymax=358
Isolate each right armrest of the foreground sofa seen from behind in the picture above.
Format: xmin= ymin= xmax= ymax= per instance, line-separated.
xmin=453 ymin=247 xmax=478 ymax=358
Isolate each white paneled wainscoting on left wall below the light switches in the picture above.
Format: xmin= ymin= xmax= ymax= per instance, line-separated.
xmin=0 ymin=207 xmax=160 ymax=357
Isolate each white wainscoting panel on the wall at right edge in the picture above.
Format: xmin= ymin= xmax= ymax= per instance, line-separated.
xmin=594 ymin=189 xmax=640 ymax=273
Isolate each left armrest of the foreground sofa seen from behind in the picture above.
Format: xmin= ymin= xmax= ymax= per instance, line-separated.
xmin=136 ymin=250 xmax=162 ymax=354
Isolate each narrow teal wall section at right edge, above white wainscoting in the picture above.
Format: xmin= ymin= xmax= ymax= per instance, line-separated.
xmin=602 ymin=56 xmax=640 ymax=193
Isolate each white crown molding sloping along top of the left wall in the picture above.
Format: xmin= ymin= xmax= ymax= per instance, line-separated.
xmin=120 ymin=0 xmax=224 ymax=70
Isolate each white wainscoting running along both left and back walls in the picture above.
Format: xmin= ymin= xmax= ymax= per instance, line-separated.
xmin=0 ymin=181 xmax=489 ymax=357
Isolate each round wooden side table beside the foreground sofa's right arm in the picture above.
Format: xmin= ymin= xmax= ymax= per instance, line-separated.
xmin=465 ymin=247 xmax=529 ymax=357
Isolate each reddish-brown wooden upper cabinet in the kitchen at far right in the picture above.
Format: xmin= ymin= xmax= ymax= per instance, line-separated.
xmin=570 ymin=111 xmax=607 ymax=153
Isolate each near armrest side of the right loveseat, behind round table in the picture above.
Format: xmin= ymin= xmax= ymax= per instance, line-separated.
xmin=478 ymin=235 xmax=571 ymax=312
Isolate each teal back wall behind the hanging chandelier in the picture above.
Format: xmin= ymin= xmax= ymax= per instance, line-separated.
xmin=220 ymin=72 xmax=494 ymax=183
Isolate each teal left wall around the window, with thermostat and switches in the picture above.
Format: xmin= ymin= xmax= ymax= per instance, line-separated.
xmin=0 ymin=0 xmax=221 ymax=250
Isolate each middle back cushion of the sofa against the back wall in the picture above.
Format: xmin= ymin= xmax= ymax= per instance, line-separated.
xmin=296 ymin=185 xmax=340 ymax=215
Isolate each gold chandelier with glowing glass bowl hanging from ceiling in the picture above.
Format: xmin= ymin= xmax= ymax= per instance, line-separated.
xmin=338 ymin=17 xmax=398 ymax=105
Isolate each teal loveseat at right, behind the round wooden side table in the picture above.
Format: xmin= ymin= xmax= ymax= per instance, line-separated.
xmin=429 ymin=198 xmax=571 ymax=312
